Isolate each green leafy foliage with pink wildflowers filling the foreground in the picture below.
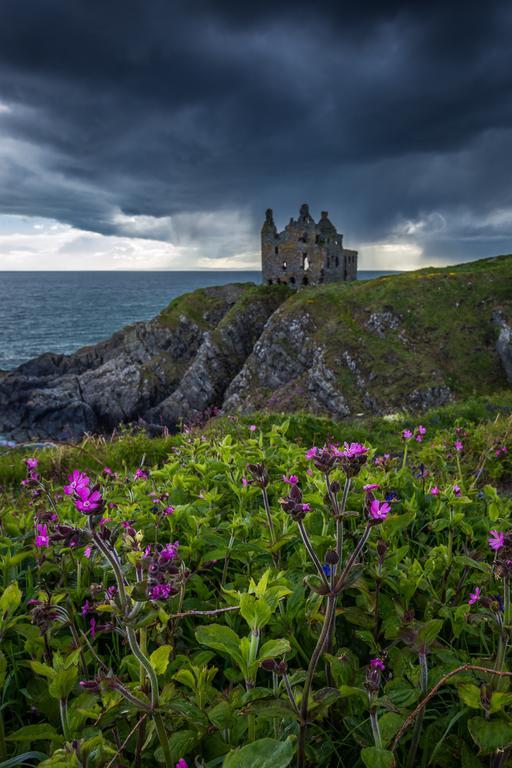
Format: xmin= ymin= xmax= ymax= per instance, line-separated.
xmin=0 ymin=400 xmax=512 ymax=768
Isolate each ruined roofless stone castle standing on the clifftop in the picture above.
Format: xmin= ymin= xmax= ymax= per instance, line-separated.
xmin=261 ymin=203 xmax=357 ymax=288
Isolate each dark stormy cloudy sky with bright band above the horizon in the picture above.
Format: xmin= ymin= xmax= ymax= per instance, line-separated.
xmin=0 ymin=0 xmax=512 ymax=269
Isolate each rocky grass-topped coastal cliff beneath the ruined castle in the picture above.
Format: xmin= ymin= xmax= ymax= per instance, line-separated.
xmin=0 ymin=256 xmax=512 ymax=440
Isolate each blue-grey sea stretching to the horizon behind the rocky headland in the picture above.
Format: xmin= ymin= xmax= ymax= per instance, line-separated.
xmin=0 ymin=270 xmax=391 ymax=371
